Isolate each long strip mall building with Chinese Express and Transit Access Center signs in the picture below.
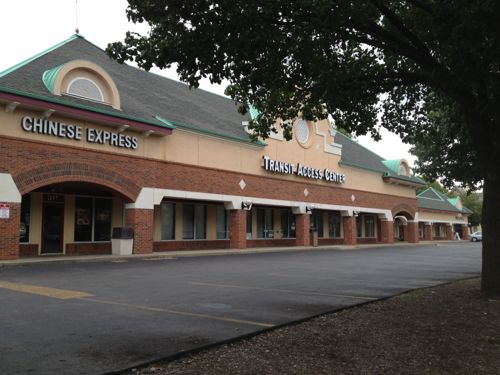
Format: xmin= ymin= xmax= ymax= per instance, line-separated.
xmin=0 ymin=35 xmax=467 ymax=259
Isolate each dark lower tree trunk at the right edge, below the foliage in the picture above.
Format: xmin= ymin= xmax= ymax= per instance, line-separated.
xmin=481 ymin=174 xmax=500 ymax=299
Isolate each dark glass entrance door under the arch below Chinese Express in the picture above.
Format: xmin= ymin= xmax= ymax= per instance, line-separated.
xmin=42 ymin=203 xmax=64 ymax=254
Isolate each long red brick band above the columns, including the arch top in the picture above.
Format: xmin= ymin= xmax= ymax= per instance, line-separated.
xmin=0 ymin=137 xmax=417 ymax=212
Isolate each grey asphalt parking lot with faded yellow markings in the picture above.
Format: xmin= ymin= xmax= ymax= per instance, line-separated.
xmin=0 ymin=242 xmax=481 ymax=374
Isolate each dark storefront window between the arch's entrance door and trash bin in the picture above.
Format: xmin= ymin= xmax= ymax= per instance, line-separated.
xmin=75 ymin=197 xmax=112 ymax=242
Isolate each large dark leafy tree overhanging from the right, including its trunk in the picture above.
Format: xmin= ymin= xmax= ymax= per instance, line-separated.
xmin=108 ymin=0 xmax=500 ymax=296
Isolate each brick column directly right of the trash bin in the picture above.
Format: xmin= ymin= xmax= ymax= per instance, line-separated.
xmin=125 ymin=208 xmax=154 ymax=254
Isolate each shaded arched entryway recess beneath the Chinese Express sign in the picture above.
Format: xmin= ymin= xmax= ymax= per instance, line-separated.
xmin=20 ymin=181 xmax=137 ymax=256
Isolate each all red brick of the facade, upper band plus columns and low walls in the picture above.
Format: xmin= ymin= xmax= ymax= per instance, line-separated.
xmin=0 ymin=137 xmax=430 ymax=259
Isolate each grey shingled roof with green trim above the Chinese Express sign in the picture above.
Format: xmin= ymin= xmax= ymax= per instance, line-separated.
xmin=0 ymin=34 xmax=256 ymax=144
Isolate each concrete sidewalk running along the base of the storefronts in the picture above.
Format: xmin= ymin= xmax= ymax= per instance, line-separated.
xmin=0 ymin=240 xmax=468 ymax=267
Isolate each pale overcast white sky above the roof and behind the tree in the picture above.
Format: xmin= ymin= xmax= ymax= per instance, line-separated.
xmin=0 ymin=0 xmax=415 ymax=165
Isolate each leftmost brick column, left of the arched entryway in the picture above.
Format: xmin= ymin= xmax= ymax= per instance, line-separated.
xmin=0 ymin=202 xmax=21 ymax=260
